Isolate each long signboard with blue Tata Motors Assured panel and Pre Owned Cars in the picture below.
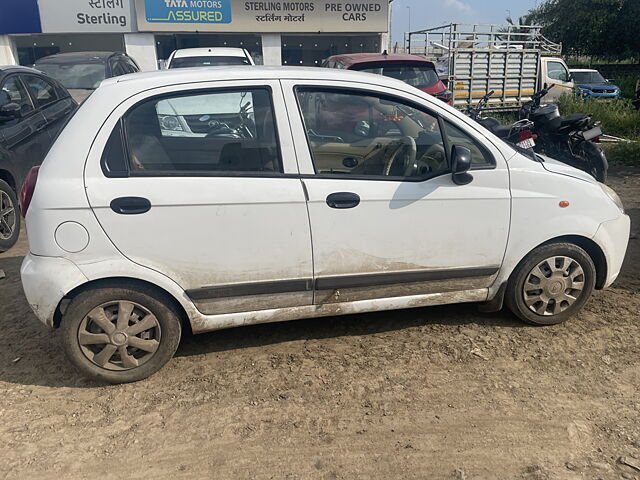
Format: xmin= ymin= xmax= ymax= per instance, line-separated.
xmin=136 ymin=0 xmax=389 ymax=33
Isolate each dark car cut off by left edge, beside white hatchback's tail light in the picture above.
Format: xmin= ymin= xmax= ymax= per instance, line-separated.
xmin=0 ymin=66 xmax=78 ymax=252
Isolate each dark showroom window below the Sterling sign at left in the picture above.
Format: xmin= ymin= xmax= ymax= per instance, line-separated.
xmin=13 ymin=33 xmax=125 ymax=67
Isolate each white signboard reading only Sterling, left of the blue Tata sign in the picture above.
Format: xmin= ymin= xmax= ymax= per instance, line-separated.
xmin=38 ymin=0 xmax=136 ymax=33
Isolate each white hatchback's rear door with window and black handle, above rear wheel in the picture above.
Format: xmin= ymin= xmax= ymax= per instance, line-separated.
xmin=85 ymin=81 xmax=313 ymax=314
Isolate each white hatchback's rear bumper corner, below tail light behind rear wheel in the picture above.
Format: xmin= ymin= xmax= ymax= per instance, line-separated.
xmin=20 ymin=253 xmax=87 ymax=327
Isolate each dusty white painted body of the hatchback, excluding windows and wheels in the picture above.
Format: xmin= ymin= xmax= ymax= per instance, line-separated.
xmin=22 ymin=67 xmax=629 ymax=331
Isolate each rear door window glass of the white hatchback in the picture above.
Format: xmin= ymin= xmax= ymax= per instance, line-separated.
xmin=124 ymin=88 xmax=283 ymax=176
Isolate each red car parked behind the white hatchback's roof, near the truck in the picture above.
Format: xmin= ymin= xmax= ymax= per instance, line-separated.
xmin=322 ymin=51 xmax=453 ymax=105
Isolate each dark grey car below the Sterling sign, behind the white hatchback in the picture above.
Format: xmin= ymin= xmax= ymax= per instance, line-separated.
xmin=35 ymin=52 xmax=140 ymax=103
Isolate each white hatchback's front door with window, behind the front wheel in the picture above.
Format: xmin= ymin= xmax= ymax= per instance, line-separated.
xmin=283 ymin=81 xmax=510 ymax=304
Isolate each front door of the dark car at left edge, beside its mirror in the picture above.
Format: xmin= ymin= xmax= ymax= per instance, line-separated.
xmin=0 ymin=74 xmax=51 ymax=188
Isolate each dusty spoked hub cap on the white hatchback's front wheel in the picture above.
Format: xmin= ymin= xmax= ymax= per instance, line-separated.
xmin=522 ymin=256 xmax=585 ymax=316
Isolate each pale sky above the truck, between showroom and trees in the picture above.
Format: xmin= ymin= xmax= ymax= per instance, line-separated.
xmin=391 ymin=0 xmax=540 ymax=44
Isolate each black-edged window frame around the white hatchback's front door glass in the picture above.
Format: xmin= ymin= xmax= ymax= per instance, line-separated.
xmin=293 ymin=84 xmax=497 ymax=183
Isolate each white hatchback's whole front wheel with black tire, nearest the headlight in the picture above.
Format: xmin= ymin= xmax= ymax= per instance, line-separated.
xmin=505 ymin=243 xmax=596 ymax=325
